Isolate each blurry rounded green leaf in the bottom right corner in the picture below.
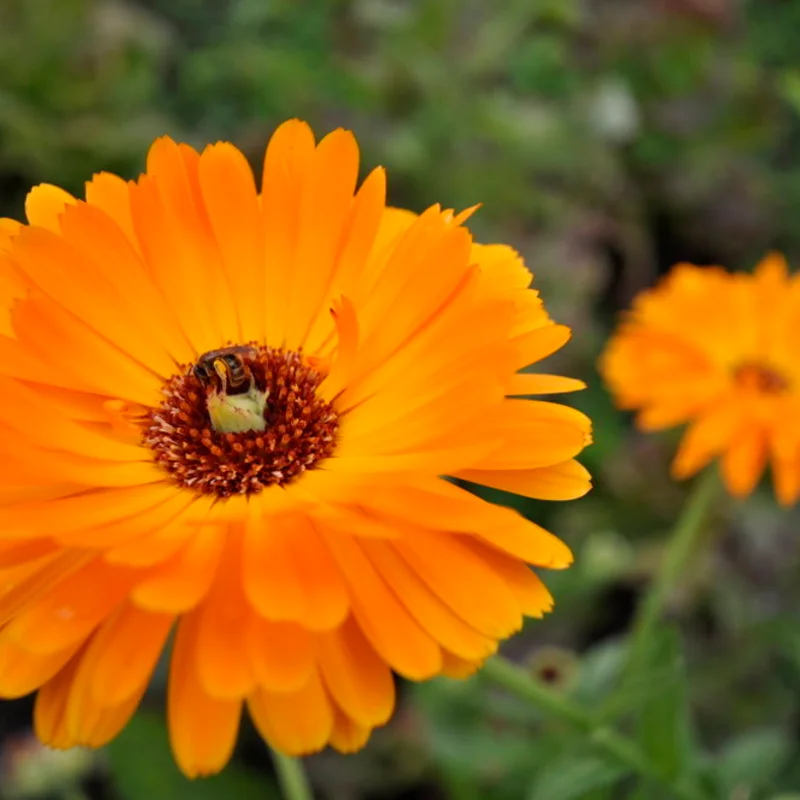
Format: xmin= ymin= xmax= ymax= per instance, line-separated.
xmin=717 ymin=728 xmax=792 ymax=793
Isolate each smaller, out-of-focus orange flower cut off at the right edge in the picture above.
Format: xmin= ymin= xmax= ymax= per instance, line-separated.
xmin=600 ymin=254 xmax=800 ymax=506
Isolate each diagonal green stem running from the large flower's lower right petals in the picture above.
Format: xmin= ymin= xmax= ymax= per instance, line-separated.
xmin=483 ymin=656 xmax=702 ymax=800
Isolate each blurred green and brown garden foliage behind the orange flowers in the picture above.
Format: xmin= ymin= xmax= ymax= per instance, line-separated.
xmin=0 ymin=0 xmax=800 ymax=800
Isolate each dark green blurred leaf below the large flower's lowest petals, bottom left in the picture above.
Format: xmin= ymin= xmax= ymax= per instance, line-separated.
xmin=106 ymin=711 xmax=279 ymax=800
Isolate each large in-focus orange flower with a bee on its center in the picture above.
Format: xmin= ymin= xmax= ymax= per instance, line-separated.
xmin=0 ymin=121 xmax=589 ymax=775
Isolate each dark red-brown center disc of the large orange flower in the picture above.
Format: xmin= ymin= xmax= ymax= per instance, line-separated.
xmin=143 ymin=345 xmax=338 ymax=497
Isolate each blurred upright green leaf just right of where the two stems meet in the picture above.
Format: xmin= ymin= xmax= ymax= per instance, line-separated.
xmin=638 ymin=629 xmax=692 ymax=780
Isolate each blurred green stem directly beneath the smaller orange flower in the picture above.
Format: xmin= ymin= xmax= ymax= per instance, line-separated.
xmin=626 ymin=469 xmax=718 ymax=676
